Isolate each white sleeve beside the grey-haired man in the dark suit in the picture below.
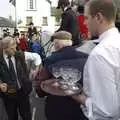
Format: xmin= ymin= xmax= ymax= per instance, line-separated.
xmin=25 ymin=52 xmax=42 ymax=66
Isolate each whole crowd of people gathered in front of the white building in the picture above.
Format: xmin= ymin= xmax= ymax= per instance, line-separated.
xmin=0 ymin=0 xmax=120 ymax=120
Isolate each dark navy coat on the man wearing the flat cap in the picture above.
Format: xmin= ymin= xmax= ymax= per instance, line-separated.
xmin=36 ymin=46 xmax=88 ymax=120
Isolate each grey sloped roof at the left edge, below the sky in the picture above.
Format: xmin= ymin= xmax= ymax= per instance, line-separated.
xmin=0 ymin=17 xmax=15 ymax=28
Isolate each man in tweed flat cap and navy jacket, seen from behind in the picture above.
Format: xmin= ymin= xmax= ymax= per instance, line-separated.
xmin=36 ymin=31 xmax=88 ymax=120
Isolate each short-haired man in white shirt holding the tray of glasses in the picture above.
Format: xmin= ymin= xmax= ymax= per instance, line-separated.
xmin=73 ymin=0 xmax=120 ymax=120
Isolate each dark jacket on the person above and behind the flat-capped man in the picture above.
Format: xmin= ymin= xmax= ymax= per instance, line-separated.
xmin=57 ymin=8 xmax=80 ymax=45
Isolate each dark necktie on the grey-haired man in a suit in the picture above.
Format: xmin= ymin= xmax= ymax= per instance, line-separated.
xmin=8 ymin=56 xmax=18 ymax=88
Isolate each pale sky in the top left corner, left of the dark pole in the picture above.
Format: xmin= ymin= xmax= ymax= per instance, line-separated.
xmin=0 ymin=0 xmax=10 ymax=18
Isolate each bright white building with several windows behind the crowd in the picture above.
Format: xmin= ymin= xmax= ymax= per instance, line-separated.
xmin=10 ymin=0 xmax=55 ymax=32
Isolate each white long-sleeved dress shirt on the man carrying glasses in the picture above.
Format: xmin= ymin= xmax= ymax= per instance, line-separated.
xmin=83 ymin=28 xmax=120 ymax=120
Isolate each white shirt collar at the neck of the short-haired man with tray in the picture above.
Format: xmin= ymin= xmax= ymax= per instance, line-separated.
xmin=99 ymin=27 xmax=119 ymax=42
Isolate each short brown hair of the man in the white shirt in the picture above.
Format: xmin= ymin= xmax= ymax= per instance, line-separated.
xmin=86 ymin=0 xmax=117 ymax=21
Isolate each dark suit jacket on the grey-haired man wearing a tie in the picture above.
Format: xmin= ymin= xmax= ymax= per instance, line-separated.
xmin=0 ymin=52 xmax=32 ymax=95
